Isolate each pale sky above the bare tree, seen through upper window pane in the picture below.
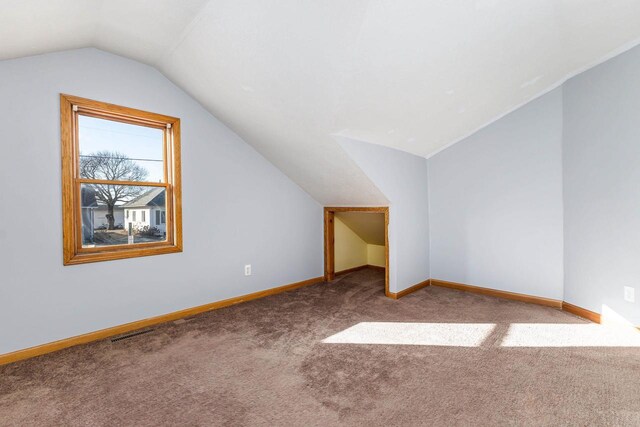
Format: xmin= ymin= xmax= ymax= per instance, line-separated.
xmin=78 ymin=115 xmax=164 ymax=182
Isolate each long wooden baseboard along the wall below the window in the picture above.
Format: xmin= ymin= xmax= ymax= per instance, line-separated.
xmin=0 ymin=277 xmax=324 ymax=365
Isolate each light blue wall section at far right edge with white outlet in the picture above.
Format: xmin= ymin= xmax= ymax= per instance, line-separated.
xmin=563 ymin=44 xmax=640 ymax=325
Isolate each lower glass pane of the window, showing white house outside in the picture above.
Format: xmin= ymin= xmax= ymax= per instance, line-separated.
xmin=80 ymin=184 xmax=167 ymax=248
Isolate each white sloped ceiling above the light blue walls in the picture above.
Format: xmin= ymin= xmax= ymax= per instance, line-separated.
xmin=0 ymin=0 xmax=640 ymax=205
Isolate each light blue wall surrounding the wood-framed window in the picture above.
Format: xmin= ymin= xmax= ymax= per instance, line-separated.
xmin=0 ymin=49 xmax=323 ymax=354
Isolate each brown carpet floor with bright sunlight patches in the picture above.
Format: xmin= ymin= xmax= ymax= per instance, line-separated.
xmin=0 ymin=270 xmax=640 ymax=426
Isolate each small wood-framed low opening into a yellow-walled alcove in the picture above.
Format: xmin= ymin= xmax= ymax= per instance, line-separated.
xmin=324 ymin=207 xmax=390 ymax=296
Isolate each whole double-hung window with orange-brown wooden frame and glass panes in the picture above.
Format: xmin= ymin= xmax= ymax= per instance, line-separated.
xmin=60 ymin=95 xmax=182 ymax=265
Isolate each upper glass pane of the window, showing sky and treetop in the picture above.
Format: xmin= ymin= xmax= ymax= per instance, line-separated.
xmin=78 ymin=115 xmax=164 ymax=182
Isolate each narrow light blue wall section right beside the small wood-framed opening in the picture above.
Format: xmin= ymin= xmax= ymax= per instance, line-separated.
xmin=338 ymin=137 xmax=430 ymax=292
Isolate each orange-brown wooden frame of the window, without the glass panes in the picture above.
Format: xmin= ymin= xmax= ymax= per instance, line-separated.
xmin=60 ymin=94 xmax=182 ymax=265
